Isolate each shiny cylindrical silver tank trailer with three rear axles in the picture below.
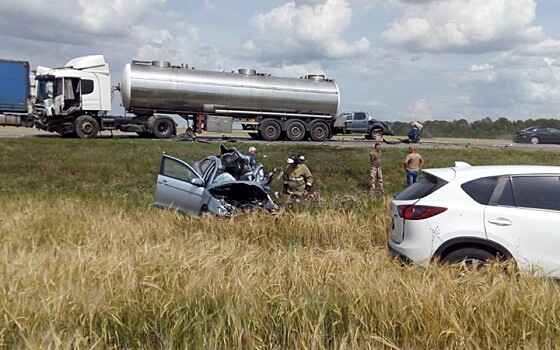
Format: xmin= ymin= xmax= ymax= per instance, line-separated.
xmin=120 ymin=61 xmax=340 ymax=141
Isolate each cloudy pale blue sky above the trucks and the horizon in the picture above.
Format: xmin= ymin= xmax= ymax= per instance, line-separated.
xmin=0 ymin=0 xmax=560 ymax=121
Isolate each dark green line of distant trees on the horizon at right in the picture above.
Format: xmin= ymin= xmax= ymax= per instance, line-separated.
xmin=393 ymin=117 xmax=560 ymax=139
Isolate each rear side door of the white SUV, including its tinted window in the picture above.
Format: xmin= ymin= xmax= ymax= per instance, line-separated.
xmin=484 ymin=175 xmax=560 ymax=278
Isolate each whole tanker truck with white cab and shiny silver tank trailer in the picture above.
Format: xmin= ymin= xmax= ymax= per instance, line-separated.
xmin=0 ymin=55 xmax=340 ymax=141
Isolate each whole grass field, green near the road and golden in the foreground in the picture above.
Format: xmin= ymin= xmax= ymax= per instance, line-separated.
xmin=0 ymin=138 xmax=560 ymax=349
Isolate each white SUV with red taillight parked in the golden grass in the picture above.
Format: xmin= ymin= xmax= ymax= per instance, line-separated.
xmin=388 ymin=162 xmax=560 ymax=278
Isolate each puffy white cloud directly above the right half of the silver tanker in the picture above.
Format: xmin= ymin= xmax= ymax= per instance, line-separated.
xmin=242 ymin=0 xmax=370 ymax=62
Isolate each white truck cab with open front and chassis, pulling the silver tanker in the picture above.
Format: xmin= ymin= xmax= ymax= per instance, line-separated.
xmin=35 ymin=55 xmax=176 ymax=138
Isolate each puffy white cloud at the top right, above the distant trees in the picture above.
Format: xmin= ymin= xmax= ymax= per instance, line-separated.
xmin=381 ymin=0 xmax=544 ymax=53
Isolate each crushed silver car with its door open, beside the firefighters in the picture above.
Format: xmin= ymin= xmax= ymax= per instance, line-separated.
xmin=154 ymin=145 xmax=278 ymax=216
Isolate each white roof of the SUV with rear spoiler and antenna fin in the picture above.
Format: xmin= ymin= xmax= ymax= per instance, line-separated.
xmin=423 ymin=163 xmax=560 ymax=182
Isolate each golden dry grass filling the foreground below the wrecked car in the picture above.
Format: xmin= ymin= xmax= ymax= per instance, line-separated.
xmin=0 ymin=197 xmax=560 ymax=349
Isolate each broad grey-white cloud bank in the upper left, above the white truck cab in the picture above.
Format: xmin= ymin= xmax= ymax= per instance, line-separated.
xmin=0 ymin=0 xmax=214 ymax=69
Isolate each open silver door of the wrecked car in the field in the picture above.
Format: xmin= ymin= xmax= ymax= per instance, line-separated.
xmin=154 ymin=155 xmax=205 ymax=213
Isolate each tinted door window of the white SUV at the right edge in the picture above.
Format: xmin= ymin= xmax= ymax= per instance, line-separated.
xmin=511 ymin=175 xmax=560 ymax=210
